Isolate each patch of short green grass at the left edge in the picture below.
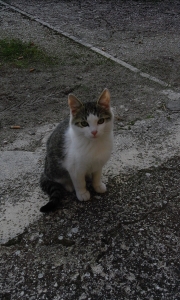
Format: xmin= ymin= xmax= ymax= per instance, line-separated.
xmin=0 ymin=39 xmax=56 ymax=67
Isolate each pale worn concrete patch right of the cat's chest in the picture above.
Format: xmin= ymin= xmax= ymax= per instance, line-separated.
xmin=104 ymin=116 xmax=180 ymax=177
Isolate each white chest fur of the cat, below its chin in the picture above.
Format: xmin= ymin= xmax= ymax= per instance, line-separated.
xmin=63 ymin=127 xmax=113 ymax=175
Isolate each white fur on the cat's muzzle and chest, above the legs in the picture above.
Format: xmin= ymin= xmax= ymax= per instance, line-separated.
xmin=63 ymin=114 xmax=113 ymax=176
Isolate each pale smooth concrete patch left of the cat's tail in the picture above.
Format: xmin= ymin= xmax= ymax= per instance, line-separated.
xmin=0 ymin=151 xmax=43 ymax=243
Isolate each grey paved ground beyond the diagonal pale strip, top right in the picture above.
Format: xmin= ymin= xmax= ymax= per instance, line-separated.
xmin=3 ymin=0 xmax=180 ymax=88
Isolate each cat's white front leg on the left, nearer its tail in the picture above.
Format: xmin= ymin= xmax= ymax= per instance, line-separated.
xmin=71 ymin=172 xmax=90 ymax=201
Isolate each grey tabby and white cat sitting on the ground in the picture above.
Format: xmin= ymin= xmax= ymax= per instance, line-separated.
xmin=40 ymin=89 xmax=114 ymax=212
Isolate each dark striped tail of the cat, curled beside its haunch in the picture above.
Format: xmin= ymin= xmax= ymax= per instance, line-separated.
xmin=40 ymin=173 xmax=64 ymax=213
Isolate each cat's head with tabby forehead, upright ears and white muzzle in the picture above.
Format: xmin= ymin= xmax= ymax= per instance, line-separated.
xmin=68 ymin=89 xmax=113 ymax=139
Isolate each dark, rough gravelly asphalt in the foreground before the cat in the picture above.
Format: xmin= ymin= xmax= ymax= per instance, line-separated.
xmin=0 ymin=157 xmax=180 ymax=300
